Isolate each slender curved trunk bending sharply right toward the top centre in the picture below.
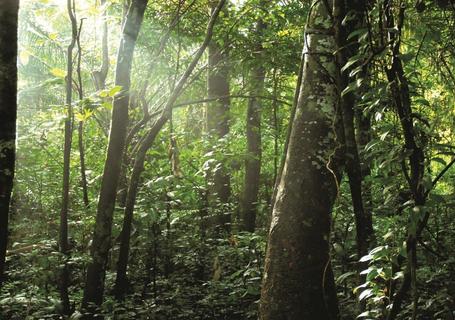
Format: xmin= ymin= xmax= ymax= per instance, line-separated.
xmin=114 ymin=0 xmax=226 ymax=299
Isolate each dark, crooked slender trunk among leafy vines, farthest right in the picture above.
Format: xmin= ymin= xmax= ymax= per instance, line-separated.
xmin=385 ymin=1 xmax=430 ymax=320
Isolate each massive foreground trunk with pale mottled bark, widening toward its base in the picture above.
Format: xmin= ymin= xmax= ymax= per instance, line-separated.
xmin=260 ymin=0 xmax=339 ymax=320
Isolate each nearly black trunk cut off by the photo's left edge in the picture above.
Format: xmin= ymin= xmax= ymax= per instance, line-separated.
xmin=0 ymin=0 xmax=19 ymax=287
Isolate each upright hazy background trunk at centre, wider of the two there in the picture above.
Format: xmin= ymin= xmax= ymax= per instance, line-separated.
xmin=207 ymin=3 xmax=231 ymax=232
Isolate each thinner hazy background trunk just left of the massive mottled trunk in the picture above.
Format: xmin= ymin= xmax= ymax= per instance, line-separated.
xmin=242 ymin=3 xmax=265 ymax=232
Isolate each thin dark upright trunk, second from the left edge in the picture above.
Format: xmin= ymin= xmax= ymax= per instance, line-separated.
xmin=59 ymin=0 xmax=78 ymax=315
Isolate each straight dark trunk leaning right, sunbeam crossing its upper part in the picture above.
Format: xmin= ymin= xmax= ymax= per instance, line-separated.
xmin=82 ymin=0 xmax=148 ymax=311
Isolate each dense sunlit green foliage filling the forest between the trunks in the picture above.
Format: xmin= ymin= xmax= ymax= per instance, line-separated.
xmin=0 ymin=0 xmax=455 ymax=319
